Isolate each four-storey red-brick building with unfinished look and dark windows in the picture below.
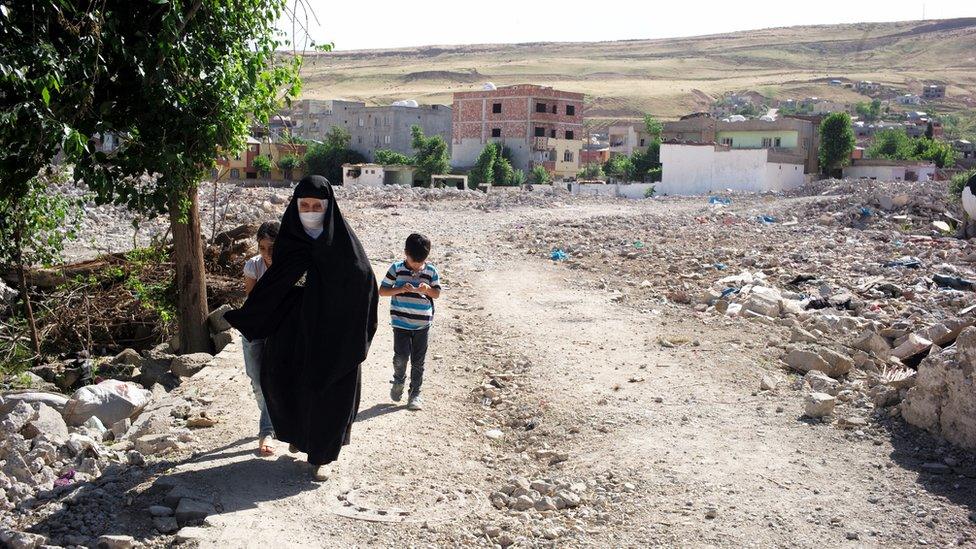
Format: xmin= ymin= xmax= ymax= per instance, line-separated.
xmin=451 ymin=84 xmax=585 ymax=178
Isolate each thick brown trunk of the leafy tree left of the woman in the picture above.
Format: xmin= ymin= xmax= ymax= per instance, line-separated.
xmin=169 ymin=185 xmax=212 ymax=353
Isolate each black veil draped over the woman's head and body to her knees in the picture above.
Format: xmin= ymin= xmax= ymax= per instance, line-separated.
xmin=225 ymin=175 xmax=379 ymax=389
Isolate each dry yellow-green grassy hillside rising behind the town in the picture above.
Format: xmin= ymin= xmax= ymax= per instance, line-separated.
xmin=303 ymin=18 xmax=976 ymax=130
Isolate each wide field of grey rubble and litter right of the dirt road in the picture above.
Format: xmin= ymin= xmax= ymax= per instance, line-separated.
xmin=508 ymin=181 xmax=976 ymax=447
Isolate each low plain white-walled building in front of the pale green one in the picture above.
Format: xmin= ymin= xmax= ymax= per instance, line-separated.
xmin=656 ymin=142 xmax=806 ymax=195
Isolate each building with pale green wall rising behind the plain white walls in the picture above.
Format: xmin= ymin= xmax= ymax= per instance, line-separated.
xmin=662 ymin=116 xmax=820 ymax=173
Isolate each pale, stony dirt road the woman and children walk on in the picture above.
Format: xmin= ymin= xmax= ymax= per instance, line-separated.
xmin=149 ymin=199 xmax=976 ymax=547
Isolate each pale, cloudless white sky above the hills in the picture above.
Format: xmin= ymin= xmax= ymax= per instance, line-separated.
xmin=279 ymin=0 xmax=976 ymax=51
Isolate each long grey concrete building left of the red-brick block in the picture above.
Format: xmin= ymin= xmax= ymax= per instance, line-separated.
xmin=282 ymin=99 xmax=451 ymax=159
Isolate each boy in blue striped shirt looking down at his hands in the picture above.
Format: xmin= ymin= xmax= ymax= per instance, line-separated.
xmin=380 ymin=233 xmax=441 ymax=411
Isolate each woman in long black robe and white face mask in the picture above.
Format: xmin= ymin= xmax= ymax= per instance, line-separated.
xmin=225 ymin=176 xmax=379 ymax=480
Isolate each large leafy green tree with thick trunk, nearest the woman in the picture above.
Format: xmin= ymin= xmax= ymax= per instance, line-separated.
xmin=69 ymin=0 xmax=301 ymax=352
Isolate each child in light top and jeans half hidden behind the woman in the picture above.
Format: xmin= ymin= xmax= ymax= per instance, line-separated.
xmin=241 ymin=221 xmax=279 ymax=456
